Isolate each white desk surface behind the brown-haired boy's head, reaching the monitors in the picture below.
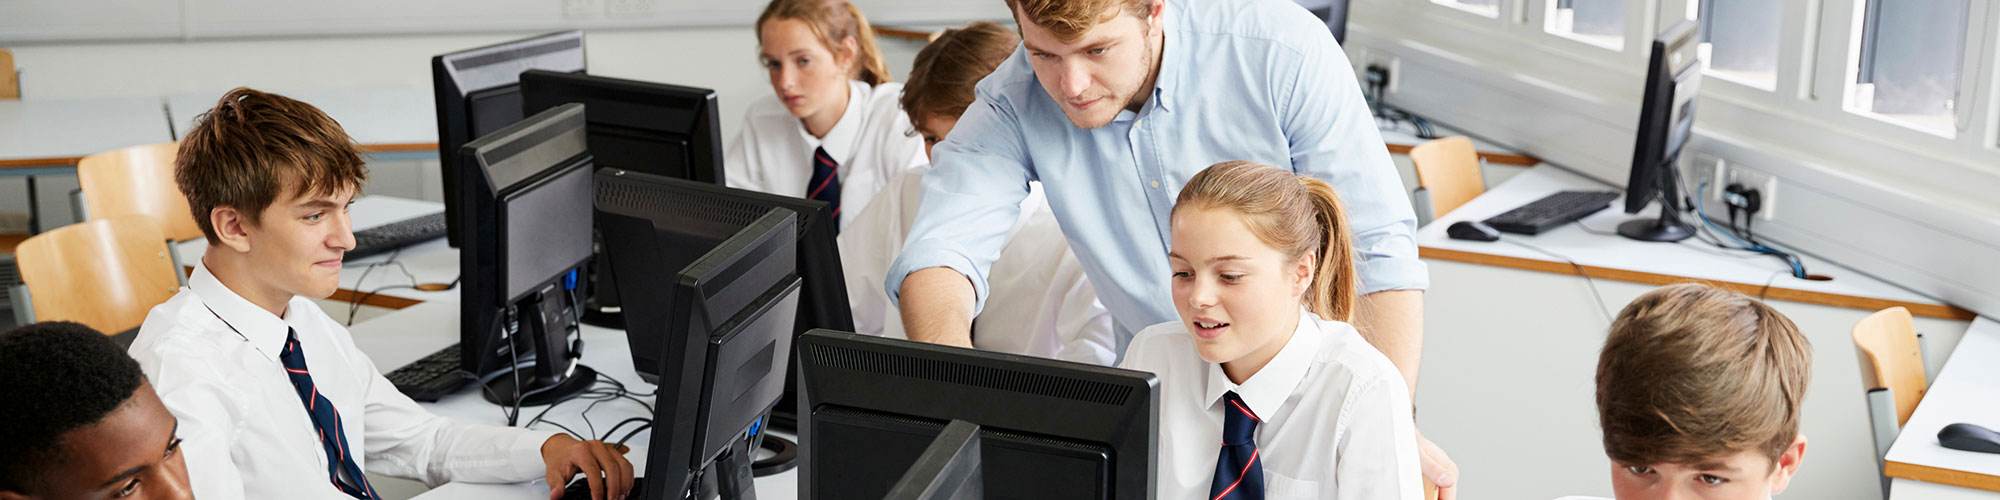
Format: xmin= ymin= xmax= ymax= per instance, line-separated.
xmin=166 ymin=88 xmax=438 ymax=152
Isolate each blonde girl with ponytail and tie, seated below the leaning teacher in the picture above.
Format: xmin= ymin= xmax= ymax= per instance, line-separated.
xmin=1120 ymin=162 xmax=1424 ymax=500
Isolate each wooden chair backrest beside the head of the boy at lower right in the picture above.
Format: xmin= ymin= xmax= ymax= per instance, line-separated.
xmin=1854 ymin=308 xmax=1930 ymax=428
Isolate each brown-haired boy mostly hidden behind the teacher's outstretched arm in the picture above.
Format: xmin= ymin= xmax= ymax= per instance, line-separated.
xmin=840 ymin=22 xmax=1130 ymax=366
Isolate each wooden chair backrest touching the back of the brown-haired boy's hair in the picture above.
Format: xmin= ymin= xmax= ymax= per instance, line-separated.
xmin=76 ymin=142 xmax=202 ymax=242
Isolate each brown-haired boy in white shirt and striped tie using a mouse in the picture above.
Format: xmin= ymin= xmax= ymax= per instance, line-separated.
xmin=130 ymin=88 xmax=632 ymax=500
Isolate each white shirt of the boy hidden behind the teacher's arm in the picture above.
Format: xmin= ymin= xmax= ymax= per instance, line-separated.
xmin=840 ymin=166 xmax=1130 ymax=366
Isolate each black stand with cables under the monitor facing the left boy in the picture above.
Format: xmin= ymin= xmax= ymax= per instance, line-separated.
xmin=486 ymin=282 xmax=598 ymax=406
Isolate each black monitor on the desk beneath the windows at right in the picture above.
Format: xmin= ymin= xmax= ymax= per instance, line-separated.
xmin=1618 ymin=20 xmax=1702 ymax=242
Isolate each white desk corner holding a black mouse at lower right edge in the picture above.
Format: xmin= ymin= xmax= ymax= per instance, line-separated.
xmin=1884 ymin=318 xmax=2000 ymax=492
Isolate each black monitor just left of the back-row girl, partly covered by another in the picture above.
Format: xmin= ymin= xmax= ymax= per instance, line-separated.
xmin=520 ymin=70 xmax=724 ymax=328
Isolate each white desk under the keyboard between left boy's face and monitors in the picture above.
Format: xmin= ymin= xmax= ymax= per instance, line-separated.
xmin=176 ymin=196 xmax=458 ymax=306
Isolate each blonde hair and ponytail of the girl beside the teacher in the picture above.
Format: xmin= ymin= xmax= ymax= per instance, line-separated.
xmin=1174 ymin=162 xmax=1360 ymax=322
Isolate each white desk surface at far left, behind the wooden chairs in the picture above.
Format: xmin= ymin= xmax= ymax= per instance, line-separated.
xmin=0 ymin=98 xmax=174 ymax=168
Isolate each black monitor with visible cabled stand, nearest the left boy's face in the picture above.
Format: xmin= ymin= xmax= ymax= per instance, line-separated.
xmin=450 ymin=104 xmax=596 ymax=406
